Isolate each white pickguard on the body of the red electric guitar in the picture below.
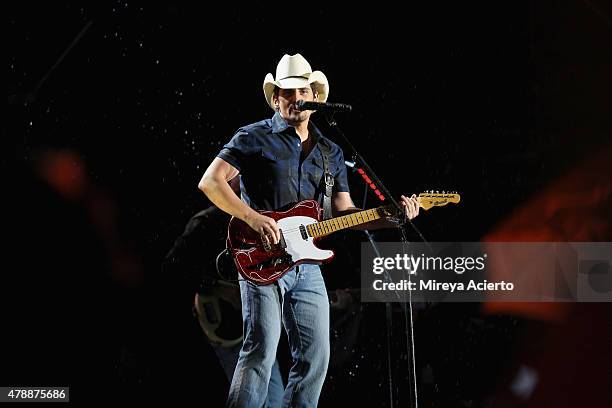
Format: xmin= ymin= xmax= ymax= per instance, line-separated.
xmin=277 ymin=216 xmax=334 ymax=262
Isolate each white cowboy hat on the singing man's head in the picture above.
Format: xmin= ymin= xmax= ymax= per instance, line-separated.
xmin=263 ymin=54 xmax=329 ymax=109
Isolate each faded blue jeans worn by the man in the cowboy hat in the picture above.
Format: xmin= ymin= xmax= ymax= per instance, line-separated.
xmin=227 ymin=265 xmax=330 ymax=408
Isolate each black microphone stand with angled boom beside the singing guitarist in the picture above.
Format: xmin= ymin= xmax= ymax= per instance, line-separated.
xmin=323 ymin=111 xmax=420 ymax=408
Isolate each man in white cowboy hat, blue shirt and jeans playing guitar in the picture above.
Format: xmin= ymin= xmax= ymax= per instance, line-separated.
xmin=199 ymin=54 xmax=419 ymax=407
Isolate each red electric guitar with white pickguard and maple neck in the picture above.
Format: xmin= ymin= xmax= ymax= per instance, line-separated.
xmin=227 ymin=193 xmax=460 ymax=285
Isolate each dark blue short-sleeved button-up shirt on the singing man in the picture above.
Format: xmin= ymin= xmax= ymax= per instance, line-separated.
xmin=217 ymin=112 xmax=349 ymax=210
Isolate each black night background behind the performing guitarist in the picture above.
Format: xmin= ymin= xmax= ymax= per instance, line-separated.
xmin=3 ymin=1 xmax=612 ymax=406
